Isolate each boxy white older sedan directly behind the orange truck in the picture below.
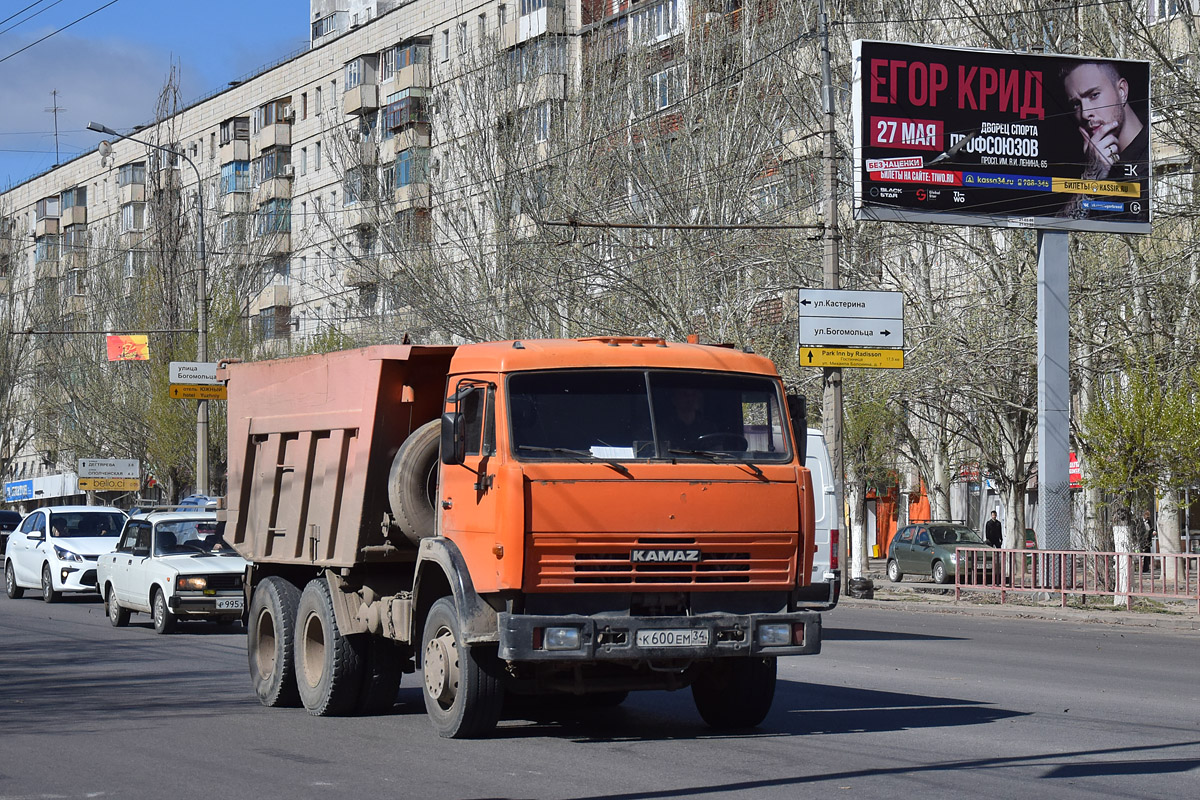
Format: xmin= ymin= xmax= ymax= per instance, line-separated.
xmin=96 ymin=511 xmax=246 ymax=633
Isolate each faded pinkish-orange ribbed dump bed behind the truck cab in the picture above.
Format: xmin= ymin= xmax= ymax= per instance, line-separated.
xmin=223 ymin=345 xmax=455 ymax=567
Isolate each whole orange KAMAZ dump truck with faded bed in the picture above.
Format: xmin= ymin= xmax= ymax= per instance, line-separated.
xmin=221 ymin=337 xmax=836 ymax=736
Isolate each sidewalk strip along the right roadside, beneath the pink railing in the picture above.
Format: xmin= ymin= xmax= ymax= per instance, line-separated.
xmin=830 ymin=559 xmax=1200 ymax=632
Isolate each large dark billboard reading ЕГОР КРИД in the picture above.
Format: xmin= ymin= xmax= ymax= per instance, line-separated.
xmin=853 ymin=40 xmax=1151 ymax=233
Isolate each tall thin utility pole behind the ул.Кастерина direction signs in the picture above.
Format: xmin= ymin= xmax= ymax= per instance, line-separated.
xmin=817 ymin=0 xmax=850 ymax=591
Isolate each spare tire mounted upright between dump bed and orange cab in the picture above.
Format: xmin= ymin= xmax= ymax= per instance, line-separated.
xmin=388 ymin=420 xmax=442 ymax=545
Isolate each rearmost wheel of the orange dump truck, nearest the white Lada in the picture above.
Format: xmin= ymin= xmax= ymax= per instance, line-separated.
xmin=246 ymin=576 xmax=300 ymax=708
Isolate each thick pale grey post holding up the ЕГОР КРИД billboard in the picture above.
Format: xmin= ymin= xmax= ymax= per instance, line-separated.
xmin=1036 ymin=230 xmax=1070 ymax=551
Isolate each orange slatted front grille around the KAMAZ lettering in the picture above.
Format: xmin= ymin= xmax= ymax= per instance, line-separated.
xmin=526 ymin=534 xmax=797 ymax=590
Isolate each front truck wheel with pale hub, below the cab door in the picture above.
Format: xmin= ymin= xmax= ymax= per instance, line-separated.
xmin=421 ymin=597 xmax=504 ymax=739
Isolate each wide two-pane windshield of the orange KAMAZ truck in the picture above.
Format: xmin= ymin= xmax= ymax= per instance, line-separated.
xmin=508 ymin=369 xmax=791 ymax=462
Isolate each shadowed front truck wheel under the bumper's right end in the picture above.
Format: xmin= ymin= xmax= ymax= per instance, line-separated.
xmin=691 ymin=658 xmax=775 ymax=728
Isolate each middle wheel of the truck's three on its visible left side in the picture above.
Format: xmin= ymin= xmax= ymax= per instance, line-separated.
xmin=294 ymin=578 xmax=362 ymax=717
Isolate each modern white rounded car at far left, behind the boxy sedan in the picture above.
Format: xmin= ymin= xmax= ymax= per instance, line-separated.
xmin=4 ymin=506 xmax=127 ymax=603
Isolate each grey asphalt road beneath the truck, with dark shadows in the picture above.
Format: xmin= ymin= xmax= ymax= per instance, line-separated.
xmin=0 ymin=595 xmax=1200 ymax=800
